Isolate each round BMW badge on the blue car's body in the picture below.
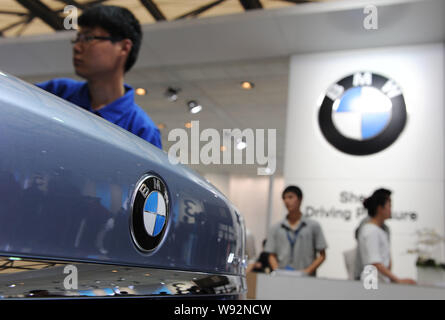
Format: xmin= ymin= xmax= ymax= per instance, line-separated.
xmin=130 ymin=174 xmax=169 ymax=252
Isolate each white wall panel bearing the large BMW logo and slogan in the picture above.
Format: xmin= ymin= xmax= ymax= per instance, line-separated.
xmin=284 ymin=43 xmax=445 ymax=279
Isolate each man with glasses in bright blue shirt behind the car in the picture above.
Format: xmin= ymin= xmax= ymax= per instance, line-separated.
xmin=37 ymin=5 xmax=162 ymax=149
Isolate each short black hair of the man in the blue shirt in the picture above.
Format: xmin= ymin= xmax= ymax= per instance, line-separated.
xmin=78 ymin=4 xmax=142 ymax=72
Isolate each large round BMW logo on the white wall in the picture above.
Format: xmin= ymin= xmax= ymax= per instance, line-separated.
xmin=318 ymin=72 xmax=407 ymax=155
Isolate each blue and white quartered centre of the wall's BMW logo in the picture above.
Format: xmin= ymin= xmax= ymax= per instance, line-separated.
xmin=332 ymin=87 xmax=392 ymax=140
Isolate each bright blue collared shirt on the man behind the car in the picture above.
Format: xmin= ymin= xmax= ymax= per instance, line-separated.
xmin=36 ymin=78 xmax=162 ymax=149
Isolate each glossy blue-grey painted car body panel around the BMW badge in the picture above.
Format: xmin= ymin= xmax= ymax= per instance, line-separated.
xmin=0 ymin=73 xmax=245 ymax=276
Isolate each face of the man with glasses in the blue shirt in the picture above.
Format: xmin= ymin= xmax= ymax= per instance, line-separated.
xmin=73 ymin=27 xmax=129 ymax=80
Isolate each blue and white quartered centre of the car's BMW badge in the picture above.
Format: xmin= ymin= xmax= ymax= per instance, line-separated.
xmin=144 ymin=191 xmax=166 ymax=237
